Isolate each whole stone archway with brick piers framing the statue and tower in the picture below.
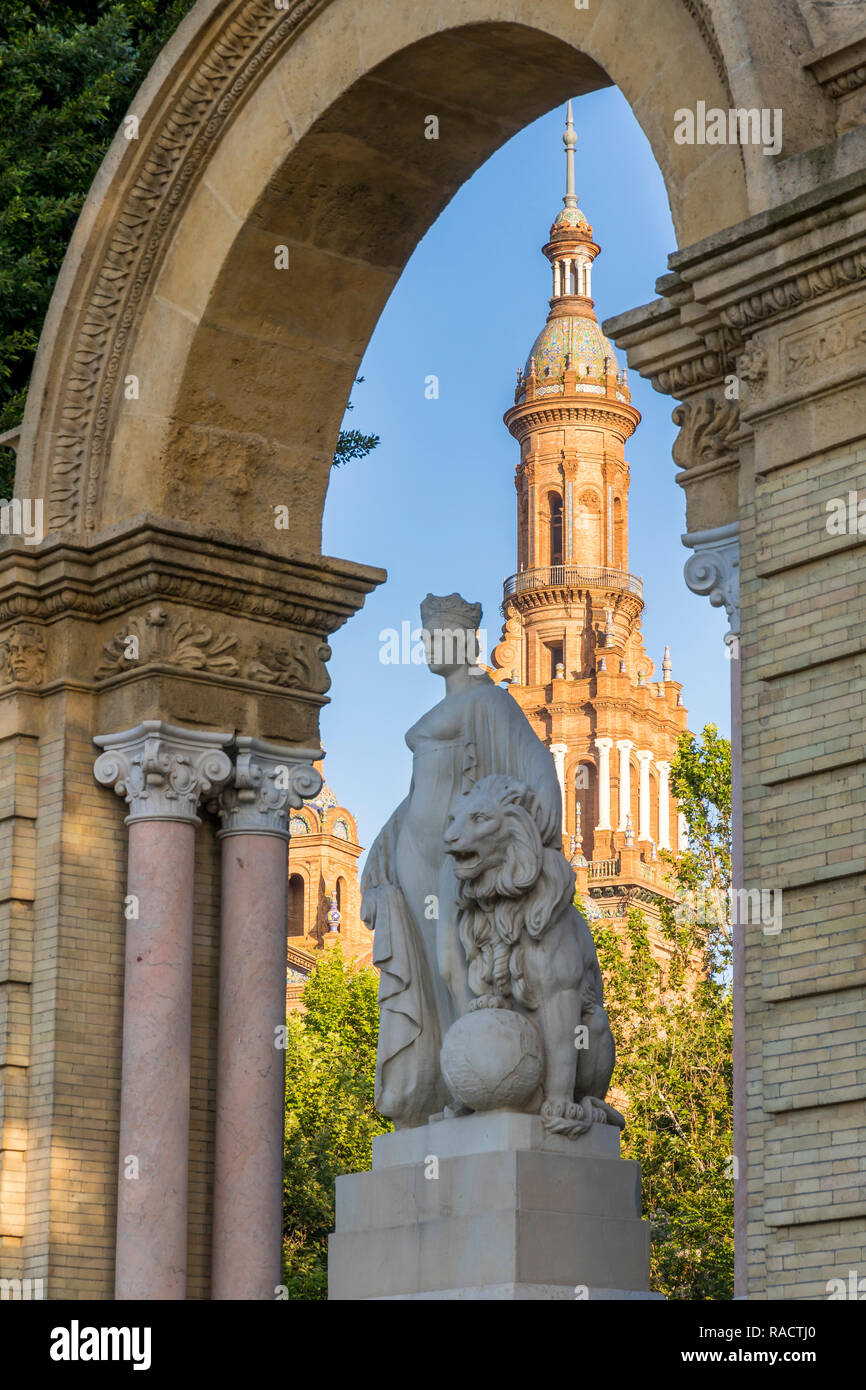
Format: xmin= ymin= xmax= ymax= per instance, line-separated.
xmin=0 ymin=0 xmax=866 ymax=1297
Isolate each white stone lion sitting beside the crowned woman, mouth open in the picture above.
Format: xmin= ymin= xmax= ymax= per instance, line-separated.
xmin=439 ymin=774 xmax=626 ymax=1138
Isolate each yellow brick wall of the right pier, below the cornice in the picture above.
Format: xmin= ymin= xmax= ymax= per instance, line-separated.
xmin=741 ymin=442 xmax=866 ymax=1298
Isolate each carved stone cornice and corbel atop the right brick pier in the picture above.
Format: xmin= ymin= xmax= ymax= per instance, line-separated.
xmin=602 ymin=170 xmax=866 ymax=534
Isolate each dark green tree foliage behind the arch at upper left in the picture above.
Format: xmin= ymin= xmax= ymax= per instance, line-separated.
xmin=0 ymin=0 xmax=378 ymax=498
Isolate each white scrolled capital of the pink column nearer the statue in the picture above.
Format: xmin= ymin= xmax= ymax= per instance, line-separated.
xmin=218 ymin=735 xmax=322 ymax=840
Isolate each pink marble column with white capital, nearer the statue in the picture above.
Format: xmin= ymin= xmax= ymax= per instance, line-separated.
xmin=211 ymin=737 xmax=321 ymax=1300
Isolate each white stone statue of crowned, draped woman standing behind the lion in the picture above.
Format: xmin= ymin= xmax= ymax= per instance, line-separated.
xmin=361 ymin=594 xmax=562 ymax=1129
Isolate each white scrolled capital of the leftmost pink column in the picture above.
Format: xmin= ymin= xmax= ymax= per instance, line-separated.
xmin=93 ymin=719 xmax=234 ymax=826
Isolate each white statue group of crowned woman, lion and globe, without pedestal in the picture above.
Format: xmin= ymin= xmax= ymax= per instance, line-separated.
xmin=361 ymin=594 xmax=623 ymax=1137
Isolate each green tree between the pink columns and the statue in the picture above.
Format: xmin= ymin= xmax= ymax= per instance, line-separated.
xmin=282 ymin=947 xmax=392 ymax=1300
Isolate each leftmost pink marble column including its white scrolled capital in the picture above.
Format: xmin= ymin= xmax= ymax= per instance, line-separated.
xmin=95 ymin=720 xmax=232 ymax=1300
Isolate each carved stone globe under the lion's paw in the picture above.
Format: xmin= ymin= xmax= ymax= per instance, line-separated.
xmin=439 ymin=1009 xmax=544 ymax=1111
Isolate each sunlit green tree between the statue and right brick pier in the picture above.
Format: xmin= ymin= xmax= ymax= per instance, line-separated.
xmin=595 ymin=724 xmax=734 ymax=1300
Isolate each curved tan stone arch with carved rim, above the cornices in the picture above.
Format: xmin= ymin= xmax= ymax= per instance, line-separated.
xmin=19 ymin=0 xmax=815 ymax=553
